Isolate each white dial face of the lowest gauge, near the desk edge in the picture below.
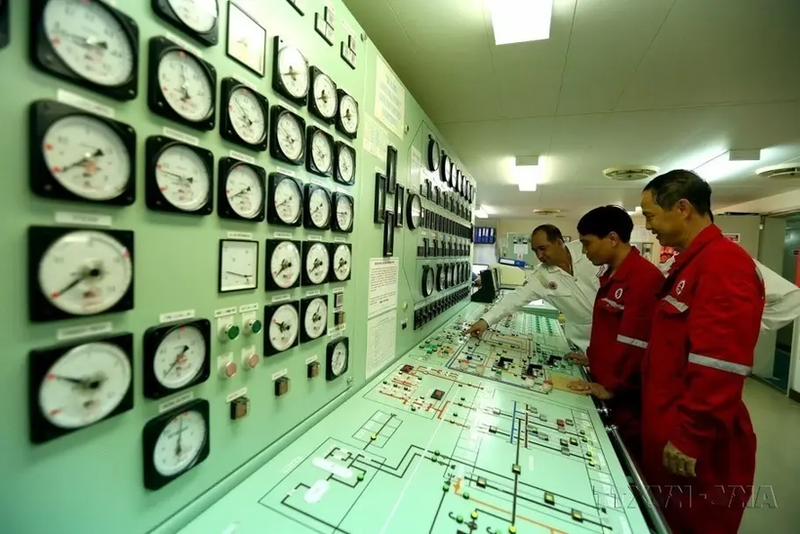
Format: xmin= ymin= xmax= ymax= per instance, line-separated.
xmin=153 ymin=410 xmax=208 ymax=477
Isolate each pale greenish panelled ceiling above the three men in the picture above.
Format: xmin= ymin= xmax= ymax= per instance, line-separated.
xmin=344 ymin=0 xmax=800 ymax=217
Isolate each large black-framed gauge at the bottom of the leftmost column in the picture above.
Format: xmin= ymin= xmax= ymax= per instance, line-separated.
xmin=29 ymin=334 xmax=133 ymax=443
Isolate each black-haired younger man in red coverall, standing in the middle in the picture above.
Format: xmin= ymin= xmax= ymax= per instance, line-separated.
xmin=569 ymin=206 xmax=664 ymax=460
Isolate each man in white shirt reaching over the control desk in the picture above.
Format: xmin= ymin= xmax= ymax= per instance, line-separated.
xmin=464 ymin=224 xmax=600 ymax=352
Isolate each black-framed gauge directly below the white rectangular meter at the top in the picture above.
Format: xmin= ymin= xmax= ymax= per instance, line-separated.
xmin=219 ymin=78 xmax=269 ymax=151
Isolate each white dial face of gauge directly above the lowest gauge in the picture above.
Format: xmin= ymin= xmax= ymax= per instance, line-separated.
xmin=153 ymin=325 xmax=208 ymax=389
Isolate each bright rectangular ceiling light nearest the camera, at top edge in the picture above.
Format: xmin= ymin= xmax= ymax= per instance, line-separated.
xmin=487 ymin=0 xmax=553 ymax=45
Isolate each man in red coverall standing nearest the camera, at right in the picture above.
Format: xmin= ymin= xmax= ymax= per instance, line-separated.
xmin=642 ymin=170 xmax=764 ymax=534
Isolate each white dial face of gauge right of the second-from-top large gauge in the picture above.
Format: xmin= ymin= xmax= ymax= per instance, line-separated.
xmin=155 ymin=145 xmax=211 ymax=211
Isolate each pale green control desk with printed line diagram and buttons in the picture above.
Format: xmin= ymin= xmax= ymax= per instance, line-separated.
xmin=181 ymin=304 xmax=649 ymax=534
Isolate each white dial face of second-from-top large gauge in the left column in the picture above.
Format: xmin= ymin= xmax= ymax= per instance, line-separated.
xmin=42 ymin=115 xmax=131 ymax=200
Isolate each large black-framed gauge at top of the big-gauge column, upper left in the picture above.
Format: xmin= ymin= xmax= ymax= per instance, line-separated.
xmin=31 ymin=0 xmax=139 ymax=100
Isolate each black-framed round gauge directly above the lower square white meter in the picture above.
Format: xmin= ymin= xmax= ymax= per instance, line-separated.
xmin=218 ymin=158 xmax=266 ymax=221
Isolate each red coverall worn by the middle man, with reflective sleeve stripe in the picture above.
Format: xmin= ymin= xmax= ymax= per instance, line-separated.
xmin=587 ymin=248 xmax=664 ymax=461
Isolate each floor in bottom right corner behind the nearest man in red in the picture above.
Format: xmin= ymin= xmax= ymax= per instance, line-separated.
xmin=739 ymin=379 xmax=800 ymax=534
